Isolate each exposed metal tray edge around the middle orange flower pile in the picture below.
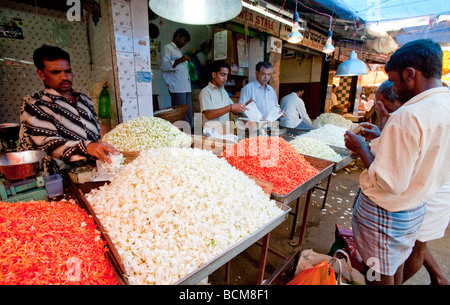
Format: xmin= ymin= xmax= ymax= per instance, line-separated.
xmin=272 ymin=155 xmax=335 ymax=205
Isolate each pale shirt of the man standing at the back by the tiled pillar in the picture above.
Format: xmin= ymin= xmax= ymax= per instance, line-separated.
xmin=160 ymin=42 xmax=191 ymax=93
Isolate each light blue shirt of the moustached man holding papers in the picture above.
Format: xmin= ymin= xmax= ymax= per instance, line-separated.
xmin=239 ymin=80 xmax=280 ymax=118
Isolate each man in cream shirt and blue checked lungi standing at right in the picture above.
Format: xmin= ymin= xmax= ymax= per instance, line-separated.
xmin=344 ymin=39 xmax=450 ymax=284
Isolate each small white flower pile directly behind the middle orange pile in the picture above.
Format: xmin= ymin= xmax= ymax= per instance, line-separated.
xmin=289 ymin=136 xmax=343 ymax=162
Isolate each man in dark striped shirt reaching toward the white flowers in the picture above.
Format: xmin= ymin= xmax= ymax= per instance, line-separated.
xmin=19 ymin=45 xmax=118 ymax=173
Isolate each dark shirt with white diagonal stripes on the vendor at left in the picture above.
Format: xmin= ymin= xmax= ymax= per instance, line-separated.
xmin=19 ymin=89 xmax=100 ymax=169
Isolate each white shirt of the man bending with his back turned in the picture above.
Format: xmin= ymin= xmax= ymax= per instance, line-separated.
xmin=280 ymin=92 xmax=312 ymax=128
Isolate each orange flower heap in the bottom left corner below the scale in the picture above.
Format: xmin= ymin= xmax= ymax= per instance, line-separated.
xmin=0 ymin=201 xmax=118 ymax=285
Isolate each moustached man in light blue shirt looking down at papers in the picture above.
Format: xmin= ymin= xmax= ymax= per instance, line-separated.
xmin=239 ymin=61 xmax=285 ymax=119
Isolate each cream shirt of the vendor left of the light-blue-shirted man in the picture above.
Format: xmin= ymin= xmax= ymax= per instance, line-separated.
xmin=199 ymin=82 xmax=233 ymax=125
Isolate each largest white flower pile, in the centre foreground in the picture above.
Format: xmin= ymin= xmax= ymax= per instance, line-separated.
xmin=86 ymin=148 xmax=282 ymax=284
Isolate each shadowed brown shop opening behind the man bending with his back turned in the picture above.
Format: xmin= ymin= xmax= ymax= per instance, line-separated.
xmin=279 ymin=50 xmax=323 ymax=119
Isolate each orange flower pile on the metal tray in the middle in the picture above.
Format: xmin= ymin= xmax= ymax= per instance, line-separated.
xmin=222 ymin=136 xmax=318 ymax=195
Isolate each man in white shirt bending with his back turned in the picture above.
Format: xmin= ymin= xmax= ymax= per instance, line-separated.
xmin=280 ymin=85 xmax=315 ymax=131
